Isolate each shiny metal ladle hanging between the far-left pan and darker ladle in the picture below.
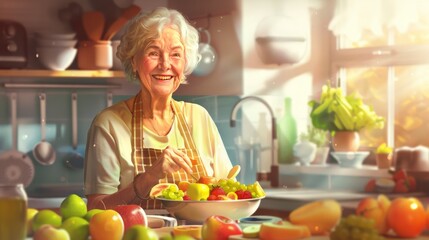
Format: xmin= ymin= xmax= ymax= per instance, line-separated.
xmin=33 ymin=93 xmax=56 ymax=165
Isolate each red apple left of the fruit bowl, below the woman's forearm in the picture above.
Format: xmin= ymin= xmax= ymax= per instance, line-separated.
xmin=114 ymin=204 xmax=147 ymax=231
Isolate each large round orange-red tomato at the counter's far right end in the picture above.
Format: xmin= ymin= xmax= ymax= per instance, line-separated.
xmin=386 ymin=197 xmax=426 ymax=238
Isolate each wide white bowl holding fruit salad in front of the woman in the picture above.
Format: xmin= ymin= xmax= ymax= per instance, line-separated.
xmin=159 ymin=197 xmax=263 ymax=223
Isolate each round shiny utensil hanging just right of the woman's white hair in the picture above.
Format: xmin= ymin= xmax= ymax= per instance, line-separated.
xmin=192 ymin=28 xmax=217 ymax=76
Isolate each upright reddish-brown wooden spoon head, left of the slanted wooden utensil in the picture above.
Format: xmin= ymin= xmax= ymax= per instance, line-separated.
xmin=82 ymin=11 xmax=106 ymax=41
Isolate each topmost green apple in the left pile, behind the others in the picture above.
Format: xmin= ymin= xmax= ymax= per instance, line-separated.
xmin=60 ymin=194 xmax=88 ymax=219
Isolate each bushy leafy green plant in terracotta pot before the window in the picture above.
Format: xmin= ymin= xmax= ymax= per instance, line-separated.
xmin=309 ymin=85 xmax=384 ymax=151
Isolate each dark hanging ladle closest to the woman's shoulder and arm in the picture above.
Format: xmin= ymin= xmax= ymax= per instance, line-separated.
xmin=65 ymin=93 xmax=84 ymax=169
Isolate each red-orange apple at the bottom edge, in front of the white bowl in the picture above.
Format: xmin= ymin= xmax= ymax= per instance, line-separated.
xmin=201 ymin=215 xmax=242 ymax=240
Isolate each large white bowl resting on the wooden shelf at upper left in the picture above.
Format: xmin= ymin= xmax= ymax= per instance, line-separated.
xmin=36 ymin=47 xmax=77 ymax=71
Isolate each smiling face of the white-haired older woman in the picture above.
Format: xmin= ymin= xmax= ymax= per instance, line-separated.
xmin=133 ymin=28 xmax=185 ymax=96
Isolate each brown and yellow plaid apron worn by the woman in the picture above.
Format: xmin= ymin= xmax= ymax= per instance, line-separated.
xmin=132 ymin=92 xmax=207 ymax=209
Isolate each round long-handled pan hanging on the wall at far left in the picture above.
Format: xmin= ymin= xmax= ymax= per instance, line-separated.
xmin=0 ymin=93 xmax=34 ymax=187
